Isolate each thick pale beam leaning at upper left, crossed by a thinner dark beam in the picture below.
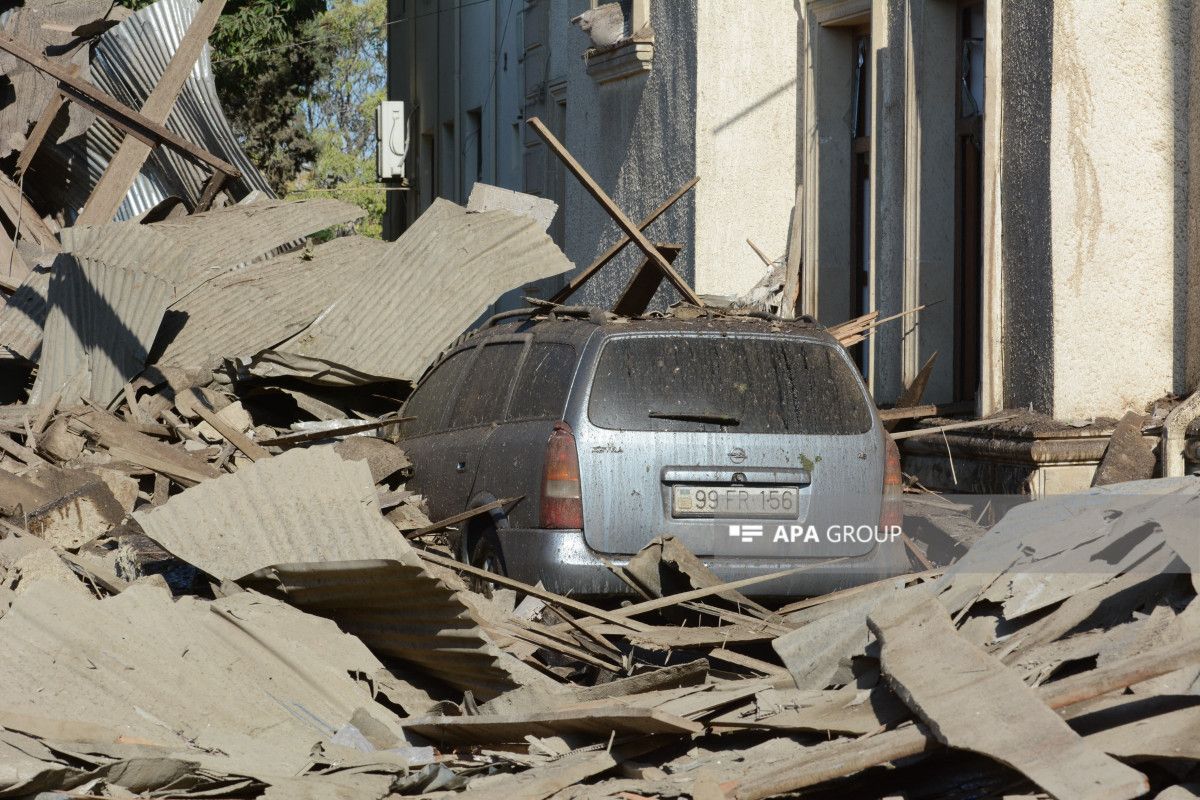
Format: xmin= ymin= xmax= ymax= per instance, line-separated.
xmin=76 ymin=0 xmax=226 ymax=225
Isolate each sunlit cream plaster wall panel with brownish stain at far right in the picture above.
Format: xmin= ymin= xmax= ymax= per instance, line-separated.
xmin=1051 ymin=0 xmax=1190 ymax=419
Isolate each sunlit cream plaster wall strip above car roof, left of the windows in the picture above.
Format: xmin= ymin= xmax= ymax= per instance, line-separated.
xmin=691 ymin=0 xmax=797 ymax=295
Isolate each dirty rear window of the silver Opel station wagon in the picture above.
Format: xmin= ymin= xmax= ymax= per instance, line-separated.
xmin=588 ymin=336 xmax=871 ymax=435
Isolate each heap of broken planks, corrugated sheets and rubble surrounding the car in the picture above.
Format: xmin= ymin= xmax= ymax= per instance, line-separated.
xmin=0 ymin=0 xmax=1200 ymax=800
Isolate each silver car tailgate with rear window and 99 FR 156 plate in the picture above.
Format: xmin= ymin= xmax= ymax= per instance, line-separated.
xmin=572 ymin=332 xmax=883 ymax=558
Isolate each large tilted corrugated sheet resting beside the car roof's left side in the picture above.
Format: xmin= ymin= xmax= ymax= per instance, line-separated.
xmin=256 ymin=199 xmax=574 ymax=384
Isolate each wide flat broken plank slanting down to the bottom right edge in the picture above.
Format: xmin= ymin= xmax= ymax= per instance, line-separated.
xmin=868 ymin=597 xmax=1150 ymax=800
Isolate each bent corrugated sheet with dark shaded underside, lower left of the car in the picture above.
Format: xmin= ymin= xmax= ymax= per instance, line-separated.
xmin=134 ymin=447 xmax=550 ymax=697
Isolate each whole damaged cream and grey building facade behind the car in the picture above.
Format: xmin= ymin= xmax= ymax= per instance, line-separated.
xmin=390 ymin=0 xmax=1200 ymax=420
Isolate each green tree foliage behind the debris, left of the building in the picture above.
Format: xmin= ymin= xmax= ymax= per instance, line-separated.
xmin=118 ymin=0 xmax=388 ymax=236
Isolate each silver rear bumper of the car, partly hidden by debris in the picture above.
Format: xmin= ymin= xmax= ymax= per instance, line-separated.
xmin=496 ymin=528 xmax=908 ymax=597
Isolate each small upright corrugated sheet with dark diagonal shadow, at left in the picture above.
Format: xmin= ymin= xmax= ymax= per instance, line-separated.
xmin=30 ymin=257 xmax=172 ymax=405
